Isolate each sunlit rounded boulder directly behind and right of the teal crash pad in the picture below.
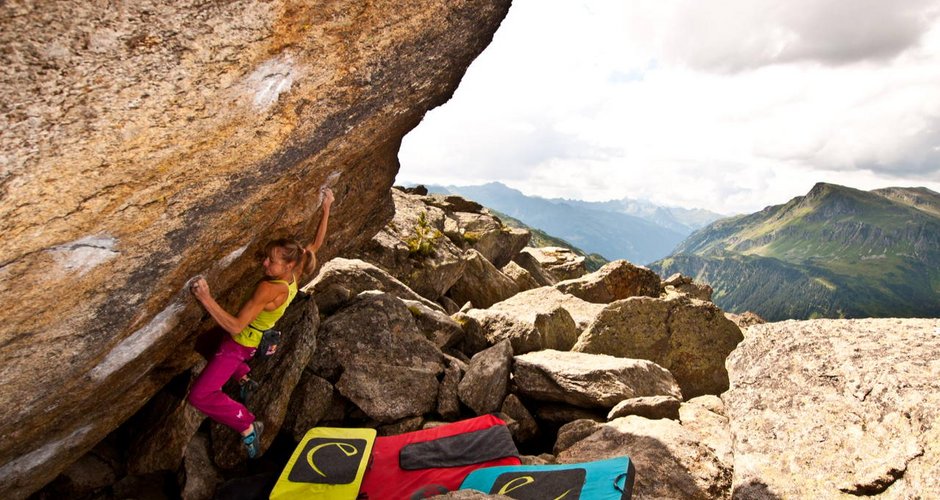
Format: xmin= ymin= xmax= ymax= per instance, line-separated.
xmin=557 ymin=416 xmax=732 ymax=500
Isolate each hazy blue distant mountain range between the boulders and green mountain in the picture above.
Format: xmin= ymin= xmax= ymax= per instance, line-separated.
xmin=426 ymin=182 xmax=722 ymax=264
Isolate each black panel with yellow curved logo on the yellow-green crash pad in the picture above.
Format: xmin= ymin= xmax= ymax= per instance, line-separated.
xmin=287 ymin=438 xmax=366 ymax=484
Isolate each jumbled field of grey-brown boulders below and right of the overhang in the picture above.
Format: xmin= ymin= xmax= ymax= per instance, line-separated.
xmin=22 ymin=186 xmax=940 ymax=499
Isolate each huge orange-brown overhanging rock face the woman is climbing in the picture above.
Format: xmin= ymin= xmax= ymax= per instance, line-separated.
xmin=0 ymin=0 xmax=509 ymax=498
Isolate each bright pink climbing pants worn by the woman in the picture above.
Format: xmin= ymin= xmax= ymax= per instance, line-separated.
xmin=187 ymin=336 xmax=255 ymax=433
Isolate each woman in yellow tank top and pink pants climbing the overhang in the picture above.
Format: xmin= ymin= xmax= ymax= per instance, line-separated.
xmin=188 ymin=189 xmax=334 ymax=458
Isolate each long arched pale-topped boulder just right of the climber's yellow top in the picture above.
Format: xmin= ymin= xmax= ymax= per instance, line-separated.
xmin=305 ymin=257 xmax=443 ymax=315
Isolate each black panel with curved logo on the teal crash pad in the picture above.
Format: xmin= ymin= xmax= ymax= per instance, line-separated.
xmin=490 ymin=469 xmax=586 ymax=500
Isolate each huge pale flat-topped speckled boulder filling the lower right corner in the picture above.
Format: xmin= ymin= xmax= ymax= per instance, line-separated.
xmin=724 ymin=319 xmax=940 ymax=498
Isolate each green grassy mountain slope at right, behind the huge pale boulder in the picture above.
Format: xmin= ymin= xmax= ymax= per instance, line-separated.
xmin=650 ymin=183 xmax=940 ymax=320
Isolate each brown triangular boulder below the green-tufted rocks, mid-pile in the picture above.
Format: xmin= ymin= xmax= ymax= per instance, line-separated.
xmin=447 ymin=249 xmax=519 ymax=309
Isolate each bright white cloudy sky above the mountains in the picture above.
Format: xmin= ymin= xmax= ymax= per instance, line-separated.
xmin=397 ymin=0 xmax=940 ymax=215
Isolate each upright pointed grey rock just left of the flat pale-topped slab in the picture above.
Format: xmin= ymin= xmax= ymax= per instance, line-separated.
xmin=458 ymin=341 xmax=512 ymax=415
